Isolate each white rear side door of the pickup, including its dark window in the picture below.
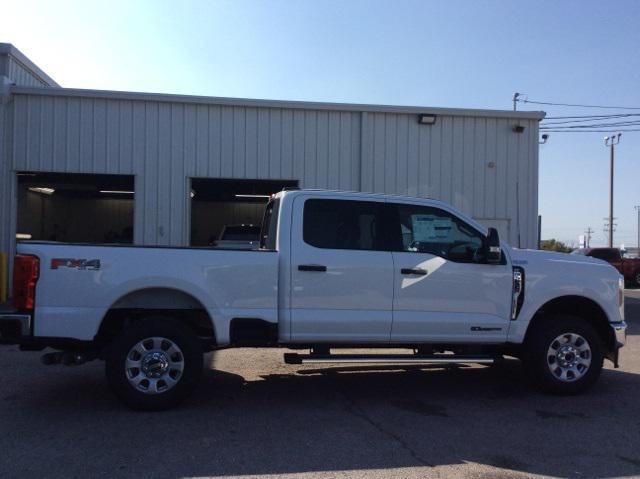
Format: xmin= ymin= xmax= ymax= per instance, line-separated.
xmin=290 ymin=195 xmax=393 ymax=343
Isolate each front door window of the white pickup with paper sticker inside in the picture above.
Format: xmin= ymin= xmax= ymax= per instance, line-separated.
xmin=394 ymin=204 xmax=484 ymax=263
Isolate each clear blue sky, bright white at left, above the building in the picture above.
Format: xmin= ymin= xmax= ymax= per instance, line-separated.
xmin=5 ymin=0 xmax=640 ymax=246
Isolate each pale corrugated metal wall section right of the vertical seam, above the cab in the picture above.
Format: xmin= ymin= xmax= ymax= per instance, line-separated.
xmin=361 ymin=113 xmax=538 ymax=247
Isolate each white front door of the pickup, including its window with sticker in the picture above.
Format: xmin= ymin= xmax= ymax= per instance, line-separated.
xmin=389 ymin=203 xmax=513 ymax=343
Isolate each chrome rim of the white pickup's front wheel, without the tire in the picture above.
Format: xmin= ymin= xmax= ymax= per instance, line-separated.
xmin=547 ymin=333 xmax=591 ymax=382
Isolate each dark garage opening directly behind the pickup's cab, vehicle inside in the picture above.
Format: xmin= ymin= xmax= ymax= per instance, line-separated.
xmin=191 ymin=178 xmax=298 ymax=246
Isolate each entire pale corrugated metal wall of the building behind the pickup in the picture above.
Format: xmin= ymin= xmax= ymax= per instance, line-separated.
xmin=2 ymin=91 xmax=538 ymax=258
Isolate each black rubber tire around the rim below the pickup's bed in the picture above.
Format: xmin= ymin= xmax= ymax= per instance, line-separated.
xmin=106 ymin=317 xmax=203 ymax=411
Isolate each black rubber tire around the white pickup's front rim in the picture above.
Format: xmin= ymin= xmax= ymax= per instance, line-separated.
xmin=522 ymin=314 xmax=604 ymax=395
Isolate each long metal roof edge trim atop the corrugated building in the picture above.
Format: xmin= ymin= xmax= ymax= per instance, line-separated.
xmin=11 ymin=86 xmax=546 ymax=120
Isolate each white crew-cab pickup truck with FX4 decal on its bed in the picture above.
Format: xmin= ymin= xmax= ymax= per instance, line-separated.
xmin=0 ymin=190 xmax=626 ymax=410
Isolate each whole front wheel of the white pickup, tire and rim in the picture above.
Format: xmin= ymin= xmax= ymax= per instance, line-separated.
xmin=523 ymin=315 xmax=604 ymax=395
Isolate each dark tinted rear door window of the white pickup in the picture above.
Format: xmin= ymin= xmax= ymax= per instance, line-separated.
xmin=302 ymin=199 xmax=386 ymax=251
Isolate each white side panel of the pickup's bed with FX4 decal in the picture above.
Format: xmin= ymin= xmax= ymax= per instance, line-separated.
xmin=17 ymin=242 xmax=278 ymax=345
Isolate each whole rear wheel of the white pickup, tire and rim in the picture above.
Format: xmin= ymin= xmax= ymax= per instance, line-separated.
xmin=106 ymin=317 xmax=202 ymax=411
